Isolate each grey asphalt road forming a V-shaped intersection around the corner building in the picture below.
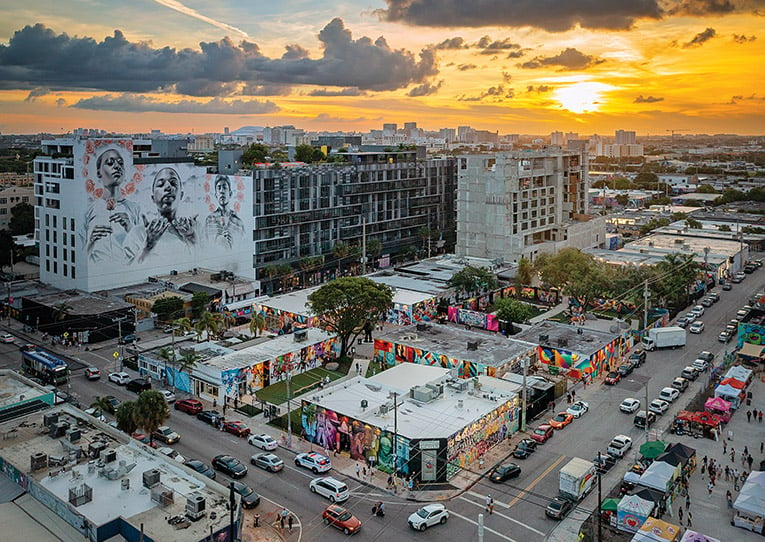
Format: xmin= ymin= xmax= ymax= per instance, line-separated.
xmin=0 ymin=270 xmax=763 ymax=542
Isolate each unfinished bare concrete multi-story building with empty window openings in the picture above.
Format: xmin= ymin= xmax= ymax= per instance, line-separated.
xmin=455 ymin=150 xmax=605 ymax=261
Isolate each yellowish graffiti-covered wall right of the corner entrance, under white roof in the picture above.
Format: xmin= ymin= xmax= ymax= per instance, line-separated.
xmin=446 ymin=399 xmax=520 ymax=478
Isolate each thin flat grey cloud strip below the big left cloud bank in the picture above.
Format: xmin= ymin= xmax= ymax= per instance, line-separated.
xmin=71 ymin=94 xmax=279 ymax=115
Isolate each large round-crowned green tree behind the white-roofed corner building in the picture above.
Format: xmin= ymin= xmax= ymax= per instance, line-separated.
xmin=307 ymin=277 xmax=393 ymax=357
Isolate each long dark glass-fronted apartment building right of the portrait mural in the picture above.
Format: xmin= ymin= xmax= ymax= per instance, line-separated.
xmin=253 ymin=150 xmax=456 ymax=284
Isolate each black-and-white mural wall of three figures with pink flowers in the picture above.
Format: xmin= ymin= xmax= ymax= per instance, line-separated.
xmin=73 ymin=139 xmax=252 ymax=294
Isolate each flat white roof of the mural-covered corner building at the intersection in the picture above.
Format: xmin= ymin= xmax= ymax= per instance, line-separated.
xmin=306 ymin=363 xmax=517 ymax=439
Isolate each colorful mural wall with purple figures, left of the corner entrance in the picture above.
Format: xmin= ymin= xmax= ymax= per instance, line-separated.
xmin=301 ymin=401 xmax=410 ymax=475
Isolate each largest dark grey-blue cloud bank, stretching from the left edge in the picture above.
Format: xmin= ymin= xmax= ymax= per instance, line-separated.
xmin=0 ymin=19 xmax=438 ymax=96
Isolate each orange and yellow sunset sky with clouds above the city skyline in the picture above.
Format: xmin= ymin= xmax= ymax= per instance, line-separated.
xmin=0 ymin=0 xmax=765 ymax=136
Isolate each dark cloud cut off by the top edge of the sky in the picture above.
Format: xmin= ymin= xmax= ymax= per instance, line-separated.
xmin=377 ymin=0 xmax=662 ymax=32
